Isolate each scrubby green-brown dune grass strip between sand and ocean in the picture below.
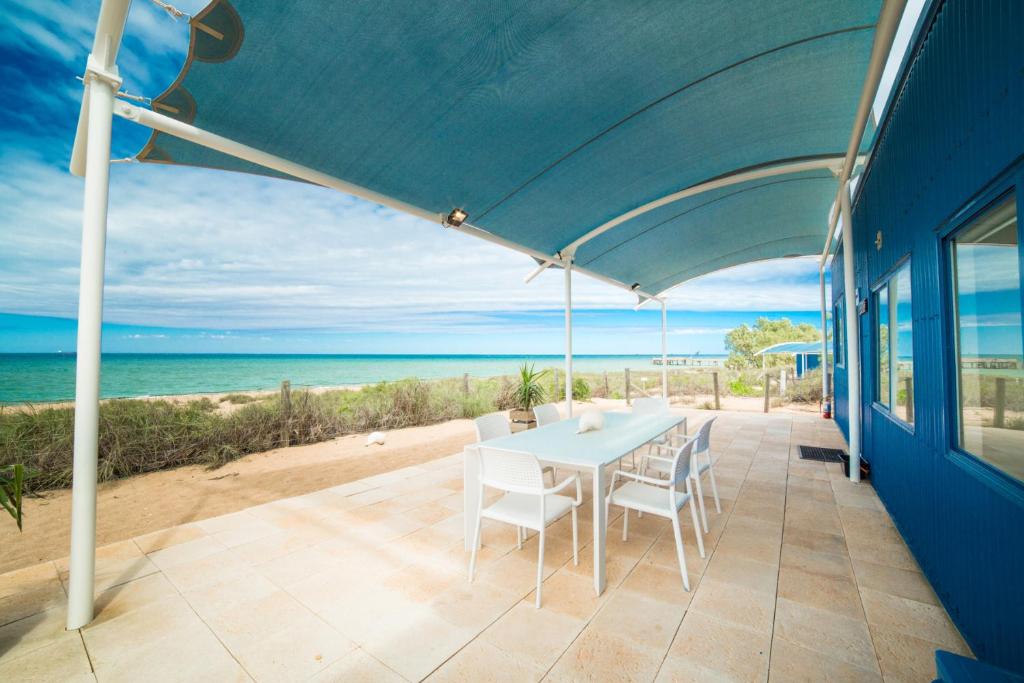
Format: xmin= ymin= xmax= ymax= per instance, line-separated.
xmin=0 ymin=371 xmax=820 ymax=490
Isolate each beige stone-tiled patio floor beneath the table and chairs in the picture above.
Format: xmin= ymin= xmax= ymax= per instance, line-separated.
xmin=0 ymin=412 xmax=968 ymax=682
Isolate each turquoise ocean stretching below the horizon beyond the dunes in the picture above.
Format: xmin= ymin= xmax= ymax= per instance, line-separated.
xmin=0 ymin=353 xmax=720 ymax=403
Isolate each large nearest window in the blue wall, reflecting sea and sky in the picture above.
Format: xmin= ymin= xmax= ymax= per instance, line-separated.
xmin=951 ymin=192 xmax=1024 ymax=479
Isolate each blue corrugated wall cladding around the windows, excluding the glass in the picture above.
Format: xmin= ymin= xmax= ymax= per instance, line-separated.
xmin=831 ymin=0 xmax=1024 ymax=672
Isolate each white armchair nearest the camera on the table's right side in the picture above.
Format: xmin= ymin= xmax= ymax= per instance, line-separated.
xmin=604 ymin=439 xmax=705 ymax=591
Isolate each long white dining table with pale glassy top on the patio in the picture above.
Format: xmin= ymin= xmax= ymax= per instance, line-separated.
xmin=463 ymin=413 xmax=686 ymax=595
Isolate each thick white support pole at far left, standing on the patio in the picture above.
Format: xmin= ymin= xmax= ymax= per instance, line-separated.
xmin=68 ymin=76 xmax=115 ymax=629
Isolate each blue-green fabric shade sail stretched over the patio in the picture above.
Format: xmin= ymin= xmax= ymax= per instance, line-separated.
xmin=139 ymin=0 xmax=881 ymax=292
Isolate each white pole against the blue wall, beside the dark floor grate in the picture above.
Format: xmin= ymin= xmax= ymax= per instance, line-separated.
xmin=840 ymin=180 xmax=860 ymax=482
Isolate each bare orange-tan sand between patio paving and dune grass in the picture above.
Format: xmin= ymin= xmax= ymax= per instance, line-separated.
xmin=0 ymin=392 xmax=817 ymax=573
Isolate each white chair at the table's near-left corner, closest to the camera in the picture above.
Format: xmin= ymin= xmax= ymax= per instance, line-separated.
xmin=469 ymin=446 xmax=583 ymax=607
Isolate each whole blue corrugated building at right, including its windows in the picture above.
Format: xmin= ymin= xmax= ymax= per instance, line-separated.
xmin=831 ymin=0 xmax=1024 ymax=672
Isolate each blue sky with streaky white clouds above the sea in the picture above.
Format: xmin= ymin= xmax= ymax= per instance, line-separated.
xmin=0 ymin=0 xmax=929 ymax=353
